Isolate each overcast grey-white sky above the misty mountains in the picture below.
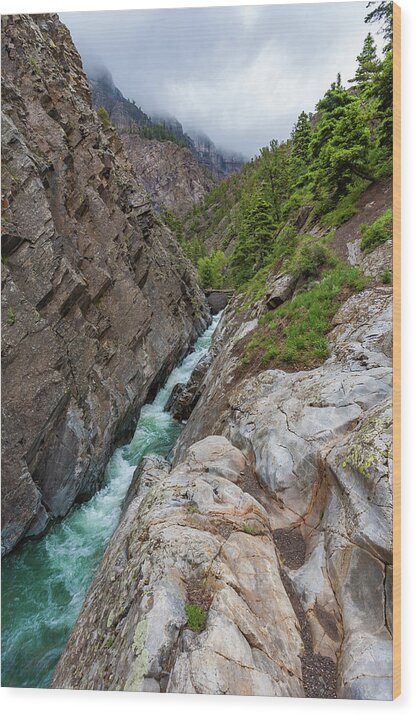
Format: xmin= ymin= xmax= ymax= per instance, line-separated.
xmin=60 ymin=2 xmax=382 ymax=157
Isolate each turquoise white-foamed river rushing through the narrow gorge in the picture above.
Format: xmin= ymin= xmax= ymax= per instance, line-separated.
xmin=2 ymin=314 xmax=220 ymax=688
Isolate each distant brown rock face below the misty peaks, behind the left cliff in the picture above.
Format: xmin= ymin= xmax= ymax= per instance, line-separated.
xmin=118 ymin=133 xmax=215 ymax=214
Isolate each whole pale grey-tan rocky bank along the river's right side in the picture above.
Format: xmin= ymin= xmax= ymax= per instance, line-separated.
xmin=54 ymin=183 xmax=392 ymax=699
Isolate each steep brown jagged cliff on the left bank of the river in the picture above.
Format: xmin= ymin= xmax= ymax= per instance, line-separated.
xmin=2 ymin=15 xmax=208 ymax=551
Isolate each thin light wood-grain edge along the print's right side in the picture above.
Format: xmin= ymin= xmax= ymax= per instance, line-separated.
xmin=393 ymin=3 xmax=401 ymax=699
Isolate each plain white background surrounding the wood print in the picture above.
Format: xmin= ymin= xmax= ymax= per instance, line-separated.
xmin=0 ymin=0 xmax=416 ymax=716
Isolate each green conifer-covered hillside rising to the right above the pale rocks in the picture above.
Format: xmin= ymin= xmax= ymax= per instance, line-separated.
xmin=180 ymin=2 xmax=392 ymax=296
